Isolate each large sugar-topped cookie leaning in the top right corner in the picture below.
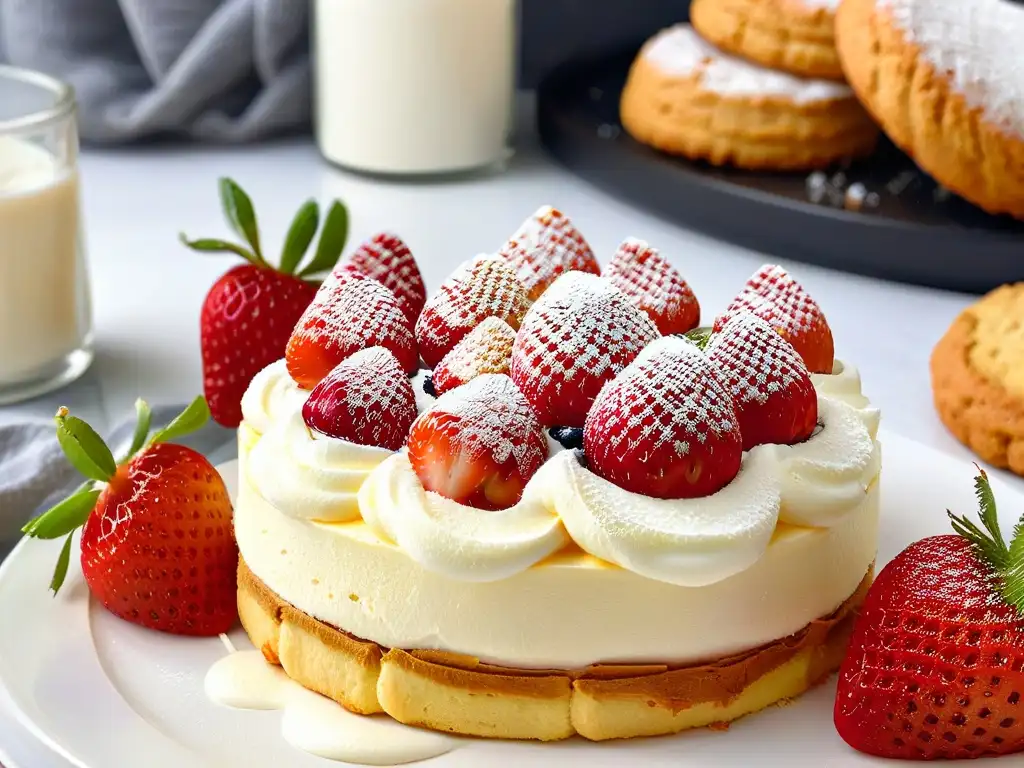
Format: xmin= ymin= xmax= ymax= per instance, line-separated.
xmin=836 ymin=0 xmax=1024 ymax=219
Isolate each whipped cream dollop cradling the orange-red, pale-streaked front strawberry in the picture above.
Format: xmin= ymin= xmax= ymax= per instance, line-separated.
xmin=359 ymin=452 xmax=568 ymax=582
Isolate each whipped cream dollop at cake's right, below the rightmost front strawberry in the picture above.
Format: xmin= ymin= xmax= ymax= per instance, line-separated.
xmin=772 ymin=395 xmax=882 ymax=527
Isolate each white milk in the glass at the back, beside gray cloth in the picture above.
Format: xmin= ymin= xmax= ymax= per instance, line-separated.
xmin=313 ymin=0 xmax=516 ymax=175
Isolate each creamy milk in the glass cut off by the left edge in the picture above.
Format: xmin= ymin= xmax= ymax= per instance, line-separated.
xmin=0 ymin=136 xmax=88 ymax=386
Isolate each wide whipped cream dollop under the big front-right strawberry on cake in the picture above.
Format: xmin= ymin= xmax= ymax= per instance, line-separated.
xmin=548 ymin=445 xmax=779 ymax=587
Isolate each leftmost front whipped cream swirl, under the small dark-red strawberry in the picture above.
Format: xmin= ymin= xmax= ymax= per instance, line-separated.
xmin=246 ymin=410 xmax=392 ymax=522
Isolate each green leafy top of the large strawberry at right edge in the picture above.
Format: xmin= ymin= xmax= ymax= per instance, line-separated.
xmin=946 ymin=465 xmax=1024 ymax=613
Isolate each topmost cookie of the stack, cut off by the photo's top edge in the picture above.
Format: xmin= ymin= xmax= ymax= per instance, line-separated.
xmin=690 ymin=0 xmax=844 ymax=81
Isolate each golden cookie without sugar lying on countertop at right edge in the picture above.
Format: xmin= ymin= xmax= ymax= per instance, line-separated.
xmin=932 ymin=283 xmax=1024 ymax=475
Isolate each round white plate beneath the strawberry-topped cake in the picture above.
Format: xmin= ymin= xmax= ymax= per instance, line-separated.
xmin=0 ymin=434 xmax=1007 ymax=768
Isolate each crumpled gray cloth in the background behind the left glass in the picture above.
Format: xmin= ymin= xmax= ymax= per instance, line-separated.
xmin=0 ymin=0 xmax=311 ymax=143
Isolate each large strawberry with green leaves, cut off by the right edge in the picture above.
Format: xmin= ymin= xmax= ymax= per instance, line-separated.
xmin=835 ymin=470 xmax=1024 ymax=760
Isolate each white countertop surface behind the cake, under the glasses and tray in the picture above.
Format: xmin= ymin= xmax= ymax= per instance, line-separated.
xmin=0 ymin=131 xmax=1007 ymax=487
